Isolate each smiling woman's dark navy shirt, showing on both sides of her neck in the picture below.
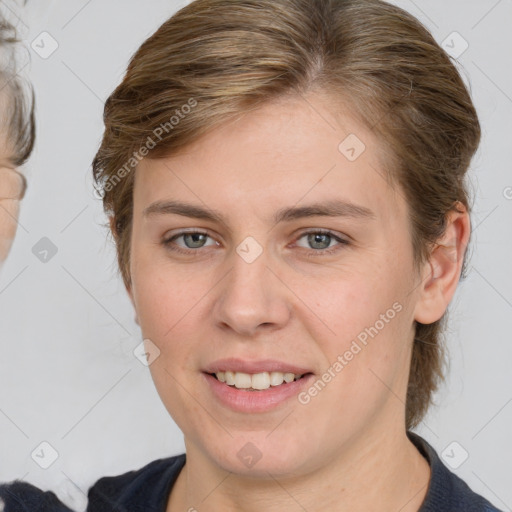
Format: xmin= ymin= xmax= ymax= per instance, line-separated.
xmin=87 ymin=432 xmax=500 ymax=512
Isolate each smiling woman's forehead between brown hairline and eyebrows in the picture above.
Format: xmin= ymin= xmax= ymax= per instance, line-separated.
xmin=134 ymin=96 xmax=404 ymax=226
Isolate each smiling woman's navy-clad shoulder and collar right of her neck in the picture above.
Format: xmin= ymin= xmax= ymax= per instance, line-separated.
xmin=407 ymin=431 xmax=501 ymax=512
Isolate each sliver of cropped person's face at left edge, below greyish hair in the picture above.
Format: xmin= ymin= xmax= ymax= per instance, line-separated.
xmin=0 ymin=164 xmax=25 ymax=266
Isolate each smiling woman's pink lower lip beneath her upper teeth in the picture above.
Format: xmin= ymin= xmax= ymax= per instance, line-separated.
xmin=203 ymin=373 xmax=313 ymax=413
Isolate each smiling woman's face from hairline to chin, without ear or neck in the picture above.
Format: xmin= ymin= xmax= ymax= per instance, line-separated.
xmin=129 ymin=95 xmax=428 ymax=476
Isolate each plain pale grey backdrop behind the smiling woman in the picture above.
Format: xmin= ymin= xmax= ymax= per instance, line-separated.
xmin=0 ymin=0 xmax=512 ymax=511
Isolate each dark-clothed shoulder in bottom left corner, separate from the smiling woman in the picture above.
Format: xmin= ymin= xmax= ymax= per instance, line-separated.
xmin=0 ymin=480 xmax=72 ymax=512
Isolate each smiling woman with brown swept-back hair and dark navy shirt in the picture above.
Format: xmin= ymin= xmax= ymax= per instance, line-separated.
xmin=88 ymin=0 xmax=497 ymax=512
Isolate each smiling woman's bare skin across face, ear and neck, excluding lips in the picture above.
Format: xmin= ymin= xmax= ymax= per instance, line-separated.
xmin=128 ymin=93 xmax=470 ymax=512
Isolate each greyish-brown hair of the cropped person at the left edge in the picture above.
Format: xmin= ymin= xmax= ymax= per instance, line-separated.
xmin=0 ymin=14 xmax=35 ymax=167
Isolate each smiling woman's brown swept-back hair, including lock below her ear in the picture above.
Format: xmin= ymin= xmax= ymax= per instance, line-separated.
xmin=93 ymin=0 xmax=480 ymax=429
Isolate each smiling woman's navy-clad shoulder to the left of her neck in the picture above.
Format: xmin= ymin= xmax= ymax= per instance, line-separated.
xmin=87 ymin=454 xmax=185 ymax=512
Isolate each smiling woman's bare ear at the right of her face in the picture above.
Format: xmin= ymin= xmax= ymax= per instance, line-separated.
xmin=414 ymin=201 xmax=471 ymax=324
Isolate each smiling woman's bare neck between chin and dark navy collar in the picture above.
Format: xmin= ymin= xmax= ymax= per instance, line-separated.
xmin=167 ymin=424 xmax=430 ymax=512
